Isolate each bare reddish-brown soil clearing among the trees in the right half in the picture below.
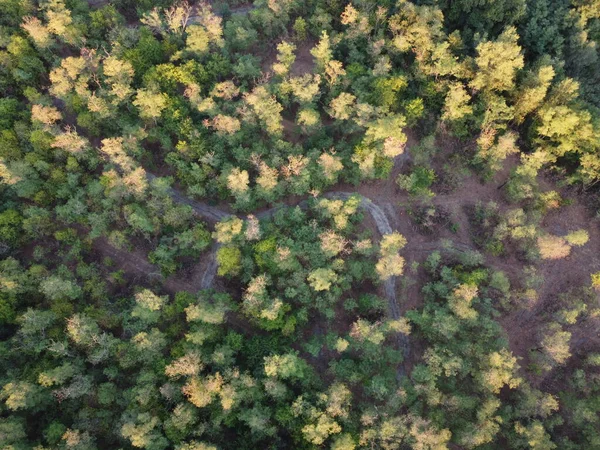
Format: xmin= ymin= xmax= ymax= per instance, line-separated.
xmin=328 ymin=129 xmax=600 ymax=382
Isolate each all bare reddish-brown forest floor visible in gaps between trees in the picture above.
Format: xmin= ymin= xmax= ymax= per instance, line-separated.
xmin=86 ymin=124 xmax=600 ymax=382
